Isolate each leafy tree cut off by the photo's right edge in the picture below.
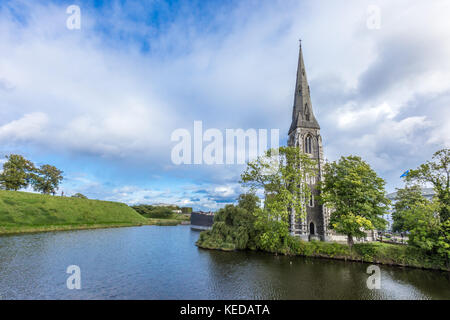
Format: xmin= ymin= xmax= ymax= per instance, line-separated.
xmin=405 ymin=149 xmax=450 ymax=221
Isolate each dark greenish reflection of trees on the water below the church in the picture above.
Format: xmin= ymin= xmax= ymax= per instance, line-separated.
xmin=201 ymin=250 xmax=450 ymax=299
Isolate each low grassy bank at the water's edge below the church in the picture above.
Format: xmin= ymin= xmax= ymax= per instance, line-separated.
xmin=197 ymin=237 xmax=450 ymax=271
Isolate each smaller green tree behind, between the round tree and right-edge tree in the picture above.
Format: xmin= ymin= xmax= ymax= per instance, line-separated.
xmin=392 ymin=185 xmax=428 ymax=232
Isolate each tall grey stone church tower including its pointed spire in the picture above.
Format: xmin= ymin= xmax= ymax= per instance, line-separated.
xmin=288 ymin=43 xmax=329 ymax=241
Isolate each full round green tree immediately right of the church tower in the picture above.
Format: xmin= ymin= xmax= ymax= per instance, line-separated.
xmin=320 ymin=156 xmax=389 ymax=247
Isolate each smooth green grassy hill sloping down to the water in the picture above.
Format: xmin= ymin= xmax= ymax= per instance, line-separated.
xmin=0 ymin=190 xmax=148 ymax=234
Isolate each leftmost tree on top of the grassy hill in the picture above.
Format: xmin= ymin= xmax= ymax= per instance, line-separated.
xmin=0 ymin=154 xmax=36 ymax=191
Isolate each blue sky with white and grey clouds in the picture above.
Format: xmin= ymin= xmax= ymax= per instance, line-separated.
xmin=0 ymin=0 xmax=450 ymax=210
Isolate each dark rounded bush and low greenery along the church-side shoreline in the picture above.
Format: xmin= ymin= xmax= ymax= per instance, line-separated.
xmin=196 ymin=201 xmax=450 ymax=271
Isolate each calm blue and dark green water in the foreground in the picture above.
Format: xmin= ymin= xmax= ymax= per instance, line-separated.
xmin=0 ymin=226 xmax=450 ymax=299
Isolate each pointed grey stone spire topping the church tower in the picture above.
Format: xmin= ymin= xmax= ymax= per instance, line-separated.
xmin=289 ymin=40 xmax=320 ymax=133
